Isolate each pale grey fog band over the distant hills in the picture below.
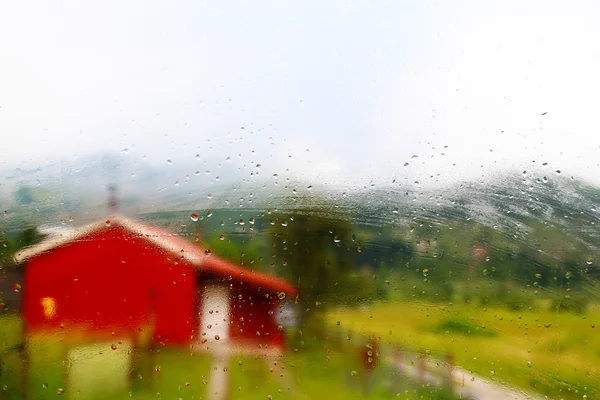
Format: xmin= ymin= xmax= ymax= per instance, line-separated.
xmin=0 ymin=152 xmax=600 ymax=255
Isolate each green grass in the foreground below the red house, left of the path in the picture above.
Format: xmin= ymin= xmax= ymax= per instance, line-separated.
xmin=0 ymin=316 xmax=454 ymax=400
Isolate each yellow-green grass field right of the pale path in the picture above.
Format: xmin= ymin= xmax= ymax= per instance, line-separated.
xmin=328 ymin=302 xmax=600 ymax=399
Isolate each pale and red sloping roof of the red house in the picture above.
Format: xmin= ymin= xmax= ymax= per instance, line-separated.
xmin=15 ymin=216 xmax=297 ymax=295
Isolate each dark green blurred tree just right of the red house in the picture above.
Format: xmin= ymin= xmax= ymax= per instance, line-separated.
xmin=271 ymin=199 xmax=356 ymax=325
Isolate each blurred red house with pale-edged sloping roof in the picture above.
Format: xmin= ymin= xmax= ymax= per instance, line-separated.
xmin=16 ymin=217 xmax=296 ymax=348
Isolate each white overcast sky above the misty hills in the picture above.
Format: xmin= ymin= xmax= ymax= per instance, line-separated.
xmin=0 ymin=0 xmax=600 ymax=189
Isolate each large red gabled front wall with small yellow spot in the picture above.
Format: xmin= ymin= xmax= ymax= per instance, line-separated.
xmin=23 ymin=226 xmax=198 ymax=343
